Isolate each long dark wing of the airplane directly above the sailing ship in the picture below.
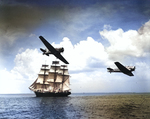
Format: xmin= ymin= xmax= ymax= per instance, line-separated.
xmin=39 ymin=36 xmax=69 ymax=64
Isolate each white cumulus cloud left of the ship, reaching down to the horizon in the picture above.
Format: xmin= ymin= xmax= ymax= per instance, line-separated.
xmin=0 ymin=49 xmax=44 ymax=93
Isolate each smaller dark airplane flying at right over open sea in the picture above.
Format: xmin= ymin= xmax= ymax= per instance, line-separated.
xmin=107 ymin=62 xmax=135 ymax=76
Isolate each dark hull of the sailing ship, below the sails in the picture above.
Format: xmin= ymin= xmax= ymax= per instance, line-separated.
xmin=34 ymin=92 xmax=71 ymax=97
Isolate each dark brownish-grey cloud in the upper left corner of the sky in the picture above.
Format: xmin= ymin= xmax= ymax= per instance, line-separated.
xmin=0 ymin=1 xmax=68 ymax=52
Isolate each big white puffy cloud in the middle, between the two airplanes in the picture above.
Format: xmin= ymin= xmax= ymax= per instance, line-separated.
xmin=60 ymin=37 xmax=107 ymax=72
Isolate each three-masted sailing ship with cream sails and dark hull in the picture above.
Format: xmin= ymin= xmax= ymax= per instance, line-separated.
xmin=29 ymin=61 xmax=71 ymax=97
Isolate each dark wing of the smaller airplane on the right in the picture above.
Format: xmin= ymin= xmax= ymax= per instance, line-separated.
xmin=115 ymin=62 xmax=134 ymax=76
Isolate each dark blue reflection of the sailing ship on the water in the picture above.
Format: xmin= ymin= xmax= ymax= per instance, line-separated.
xmin=37 ymin=97 xmax=69 ymax=119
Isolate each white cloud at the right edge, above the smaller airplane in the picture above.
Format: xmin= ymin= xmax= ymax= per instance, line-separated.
xmin=100 ymin=21 xmax=150 ymax=60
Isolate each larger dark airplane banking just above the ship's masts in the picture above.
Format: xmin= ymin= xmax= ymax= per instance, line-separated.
xmin=39 ymin=36 xmax=69 ymax=64
